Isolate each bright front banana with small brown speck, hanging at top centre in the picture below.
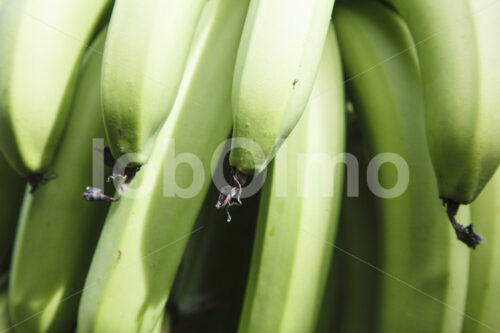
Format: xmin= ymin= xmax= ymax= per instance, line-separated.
xmin=229 ymin=0 xmax=334 ymax=174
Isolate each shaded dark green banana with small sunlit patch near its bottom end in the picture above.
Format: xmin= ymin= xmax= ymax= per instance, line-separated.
xmin=9 ymin=30 xmax=107 ymax=332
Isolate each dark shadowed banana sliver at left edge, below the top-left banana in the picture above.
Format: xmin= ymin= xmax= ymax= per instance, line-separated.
xmin=0 ymin=153 xmax=26 ymax=275
